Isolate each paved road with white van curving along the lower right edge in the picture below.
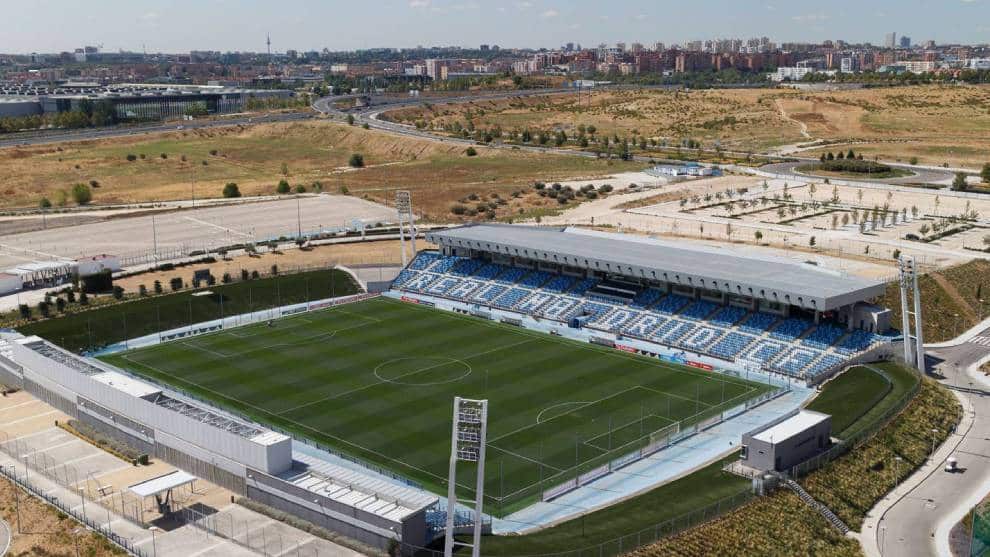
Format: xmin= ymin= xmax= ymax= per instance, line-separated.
xmin=875 ymin=328 xmax=990 ymax=557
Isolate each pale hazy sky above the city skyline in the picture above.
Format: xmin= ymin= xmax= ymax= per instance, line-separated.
xmin=7 ymin=0 xmax=990 ymax=52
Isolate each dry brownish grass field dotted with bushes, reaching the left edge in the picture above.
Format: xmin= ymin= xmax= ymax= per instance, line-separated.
xmin=0 ymin=122 xmax=641 ymax=215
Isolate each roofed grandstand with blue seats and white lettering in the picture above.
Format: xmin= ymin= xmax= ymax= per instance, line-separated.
xmin=392 ymin=224 xmax=890 ymax=383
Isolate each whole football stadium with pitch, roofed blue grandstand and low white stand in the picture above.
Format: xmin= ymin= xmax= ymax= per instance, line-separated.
xmin=0 ymin=224 xmax=891 ymax=547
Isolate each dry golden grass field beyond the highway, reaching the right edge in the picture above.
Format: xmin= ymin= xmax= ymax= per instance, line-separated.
xmin=388 ymin=82 xmax=990 ymax=167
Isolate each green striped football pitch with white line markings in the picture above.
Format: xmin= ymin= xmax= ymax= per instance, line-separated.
xmin=104 ymin=298 xmax=767 ymax=511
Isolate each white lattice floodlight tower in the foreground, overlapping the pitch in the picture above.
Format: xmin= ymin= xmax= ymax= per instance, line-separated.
xmin=443 ymin=397 xmax=488 ymax=557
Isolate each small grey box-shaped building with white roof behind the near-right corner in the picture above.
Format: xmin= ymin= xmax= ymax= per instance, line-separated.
xmin=739 ymin=410 xmax=832 ymax=472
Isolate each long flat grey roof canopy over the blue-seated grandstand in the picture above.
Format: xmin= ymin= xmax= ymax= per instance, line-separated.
xmin=426 ymin=224 xmax=885 ymax=311
